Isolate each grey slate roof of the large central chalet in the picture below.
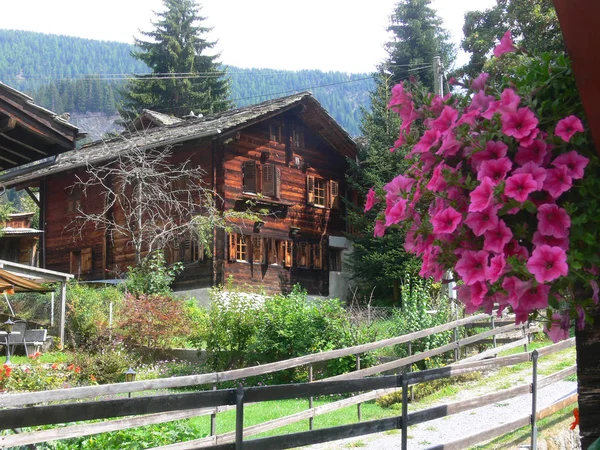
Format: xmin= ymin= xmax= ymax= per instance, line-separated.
xmin=3 ymin=92 xmax=356 ymax=186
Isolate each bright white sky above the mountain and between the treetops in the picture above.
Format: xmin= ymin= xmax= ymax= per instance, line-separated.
xmin=0 ymin=0 xmax=495 ymax=73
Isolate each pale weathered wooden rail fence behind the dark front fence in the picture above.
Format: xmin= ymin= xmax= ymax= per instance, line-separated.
xmin=0 ymin=314 xmax=544 ymax=449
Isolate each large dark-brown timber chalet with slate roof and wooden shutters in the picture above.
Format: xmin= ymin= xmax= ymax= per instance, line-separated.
xmin=4 ymin=92 xmax=357 ymax=296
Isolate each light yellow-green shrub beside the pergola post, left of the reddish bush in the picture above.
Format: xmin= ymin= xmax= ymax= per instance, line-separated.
xmin=67 ymin=283 xmax=123 ymax=346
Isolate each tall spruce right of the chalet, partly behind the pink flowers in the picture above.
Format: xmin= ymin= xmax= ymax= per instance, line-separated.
xmin=347 ymin=0 xmax=454 ymax=305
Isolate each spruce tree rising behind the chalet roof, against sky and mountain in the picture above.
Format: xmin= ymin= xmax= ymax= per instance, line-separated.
xmin=119 ymin=0 xmax=231 ymax=121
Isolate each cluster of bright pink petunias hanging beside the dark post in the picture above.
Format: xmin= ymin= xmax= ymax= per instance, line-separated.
xmin=365 ymin=33 xmax=588 ymax=342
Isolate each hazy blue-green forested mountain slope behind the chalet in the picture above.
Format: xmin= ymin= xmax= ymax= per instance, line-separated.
xmin=0 ymin=30 xmax=373 ymax=136
